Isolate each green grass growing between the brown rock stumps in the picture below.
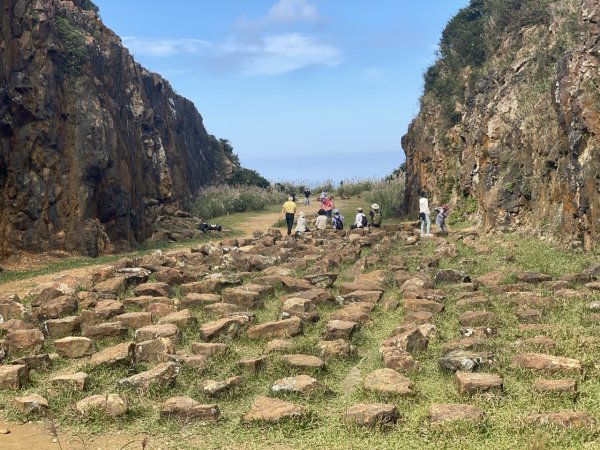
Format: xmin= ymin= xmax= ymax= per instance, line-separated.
xmin=0 ymin=209 xmax=600 ymax=449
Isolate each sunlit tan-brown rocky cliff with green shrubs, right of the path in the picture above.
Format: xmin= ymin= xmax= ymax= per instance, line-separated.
xmin=402 ymin=0 xmax=600 ymax=248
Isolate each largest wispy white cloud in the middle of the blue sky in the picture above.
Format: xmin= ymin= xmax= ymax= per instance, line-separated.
xmin=241 ymin=33 xmax=342 ymax=76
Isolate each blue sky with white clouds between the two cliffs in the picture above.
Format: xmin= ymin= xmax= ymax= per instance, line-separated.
xmin=95 ymin=0 xmax=468 ymax=182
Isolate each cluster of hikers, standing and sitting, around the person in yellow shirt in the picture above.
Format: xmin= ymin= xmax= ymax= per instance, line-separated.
xmin=281 ymin=188 xmax=383 ymax=236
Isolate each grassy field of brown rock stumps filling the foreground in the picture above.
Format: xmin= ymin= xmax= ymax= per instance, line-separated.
xmin=0 ymin=224 xmax=600 ymax=449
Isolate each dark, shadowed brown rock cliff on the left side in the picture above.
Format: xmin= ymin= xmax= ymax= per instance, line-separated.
xmin=0 ymin=0 xmax=227 ymax=255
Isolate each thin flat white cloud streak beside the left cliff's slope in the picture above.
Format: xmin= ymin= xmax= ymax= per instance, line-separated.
xmin=122 ymin=36 xmax=212 ymax=57
